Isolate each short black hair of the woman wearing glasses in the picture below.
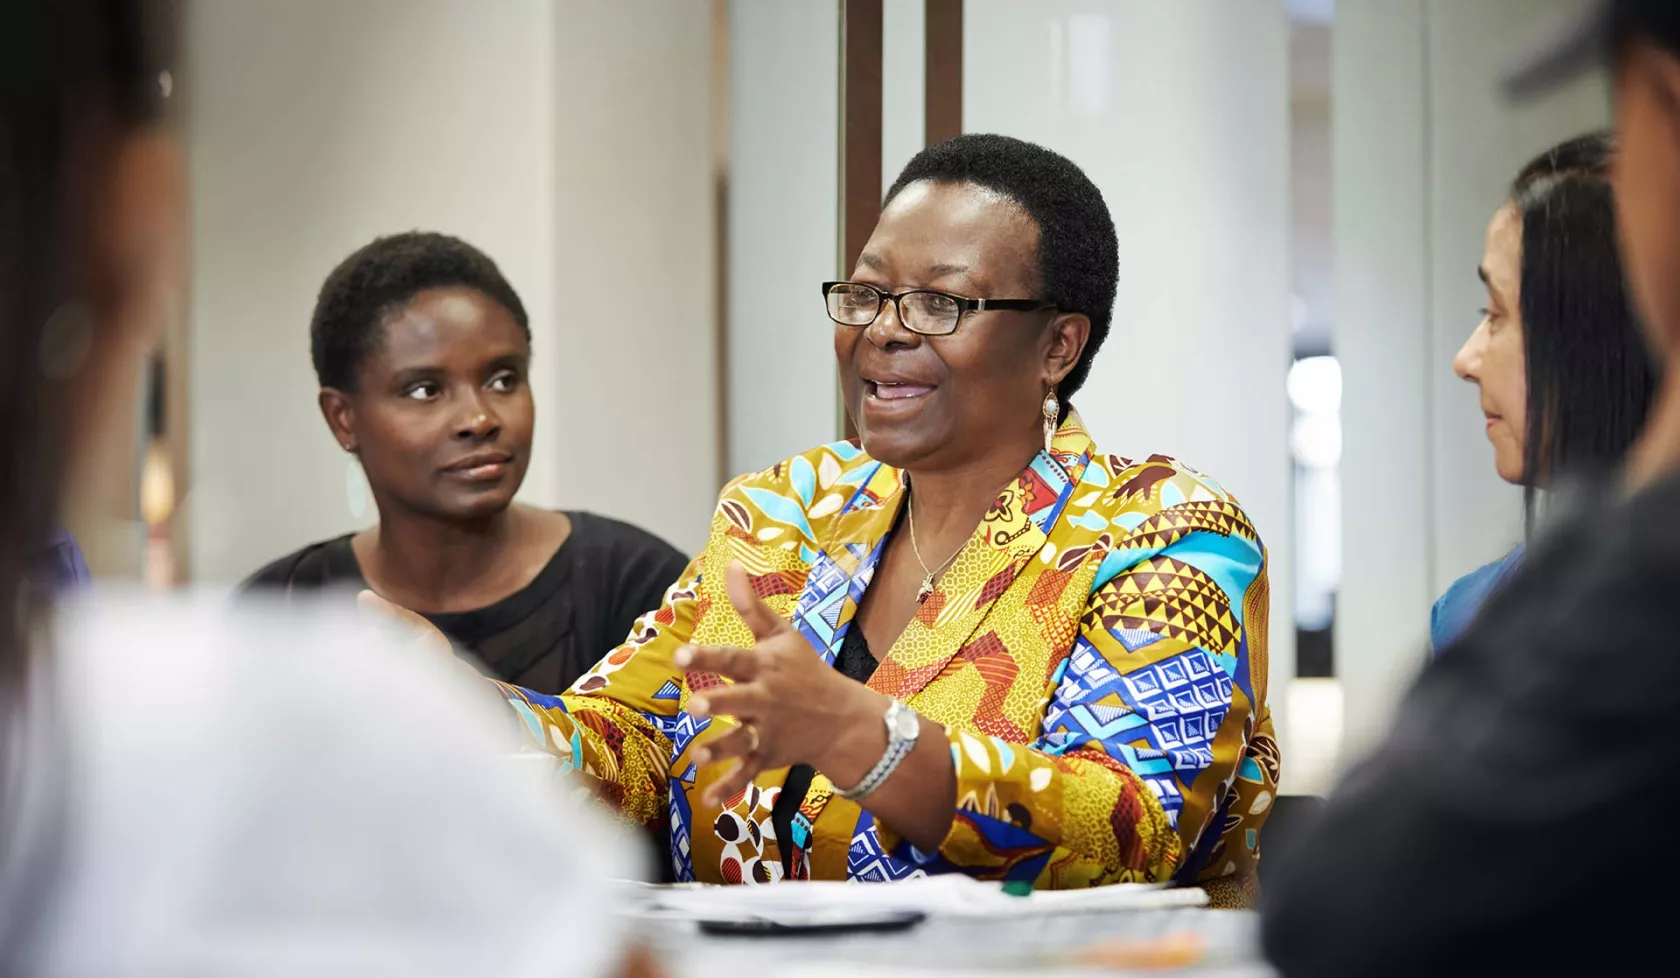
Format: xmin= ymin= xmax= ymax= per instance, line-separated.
xmin=882 ymin=133 xmax=1121 ymax=402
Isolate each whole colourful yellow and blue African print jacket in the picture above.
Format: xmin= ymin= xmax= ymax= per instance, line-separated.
xmin=504 ymin=413 xmax=1278 ymax=887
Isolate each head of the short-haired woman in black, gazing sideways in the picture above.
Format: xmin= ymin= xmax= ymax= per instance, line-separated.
xmin=309 ymin=232 xmax=536 ymax=521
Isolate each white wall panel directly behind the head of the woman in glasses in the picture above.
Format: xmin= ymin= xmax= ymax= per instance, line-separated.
xmin=963 ymin=0 xmax=1295 ymax=778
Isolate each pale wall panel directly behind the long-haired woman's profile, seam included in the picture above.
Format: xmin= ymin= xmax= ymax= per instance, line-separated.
xmin=1332 ymin=0 xmax=1608 ymax=756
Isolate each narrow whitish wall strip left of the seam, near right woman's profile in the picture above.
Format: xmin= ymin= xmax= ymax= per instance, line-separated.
xmin=1331 ymin=0 xmax=1431 ymax=756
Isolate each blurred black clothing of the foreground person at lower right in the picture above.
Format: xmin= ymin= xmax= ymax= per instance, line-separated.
xmin=1263 ymin=479 xmax=1680 ymax=978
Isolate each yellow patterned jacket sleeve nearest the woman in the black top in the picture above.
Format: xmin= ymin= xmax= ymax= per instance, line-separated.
xmin=497 ymin=558 xmax=704 ymax=825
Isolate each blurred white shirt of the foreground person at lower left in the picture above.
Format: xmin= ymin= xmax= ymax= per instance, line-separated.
xmin=0 ymin=597 xmax=642 ymax=978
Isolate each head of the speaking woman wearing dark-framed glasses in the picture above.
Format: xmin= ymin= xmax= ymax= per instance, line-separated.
xmin=828 ymin=134 xmax=1119 ymax=469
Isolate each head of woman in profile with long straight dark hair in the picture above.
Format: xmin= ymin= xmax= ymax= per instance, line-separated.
xmin=1453 ymin=133 xmax=1655 ymax=492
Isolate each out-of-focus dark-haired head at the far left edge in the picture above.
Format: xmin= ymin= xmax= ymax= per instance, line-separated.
xmin=0 ymin=0 xmax=185 ymax=676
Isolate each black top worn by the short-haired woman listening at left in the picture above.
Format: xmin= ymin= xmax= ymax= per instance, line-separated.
xmin=244 ymin=513 xmax=687 ymax=692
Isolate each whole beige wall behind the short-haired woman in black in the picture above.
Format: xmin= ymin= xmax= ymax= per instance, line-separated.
xmin=186 ymin=0 xmax=717 ymax=581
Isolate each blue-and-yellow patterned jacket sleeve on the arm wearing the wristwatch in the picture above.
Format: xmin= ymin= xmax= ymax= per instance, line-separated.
xmin=894 ymin=472 xmax=1270 ymax=887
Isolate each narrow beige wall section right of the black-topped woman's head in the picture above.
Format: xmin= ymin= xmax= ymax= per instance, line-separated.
xmin=544 ymin=0 xmax=715 ymax=553
